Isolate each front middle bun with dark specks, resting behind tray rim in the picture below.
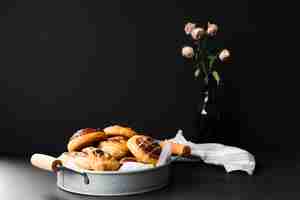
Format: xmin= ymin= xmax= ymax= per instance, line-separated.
xmin=88 ymin=148 xmax=120 ymax=171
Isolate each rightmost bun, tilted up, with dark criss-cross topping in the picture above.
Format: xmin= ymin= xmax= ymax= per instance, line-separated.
xmin=127 ymin=135 xmax=161 ymax=164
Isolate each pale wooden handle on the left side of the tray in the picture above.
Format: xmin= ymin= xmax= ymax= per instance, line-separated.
xmin=30 ymin=153 xmax=62 ymax=172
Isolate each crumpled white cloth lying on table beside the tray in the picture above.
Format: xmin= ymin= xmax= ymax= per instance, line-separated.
xmin=170 ymin=130 xmax=255 ymax=175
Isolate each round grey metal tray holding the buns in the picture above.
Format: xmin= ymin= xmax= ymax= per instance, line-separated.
xmin=57 ymin=163 xmax=171 ymax=196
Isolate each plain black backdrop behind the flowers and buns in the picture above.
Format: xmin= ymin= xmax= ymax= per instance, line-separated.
xmin=0 ymin=0 xmax=299 ymax=154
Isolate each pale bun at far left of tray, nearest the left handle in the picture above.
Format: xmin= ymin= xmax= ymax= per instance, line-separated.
xmin=58 ymin=151 xmax=91 ymax=170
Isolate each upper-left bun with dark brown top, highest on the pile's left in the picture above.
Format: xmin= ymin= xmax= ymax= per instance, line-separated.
xmin=68 ymin=128 xmax=106 ymax=152
